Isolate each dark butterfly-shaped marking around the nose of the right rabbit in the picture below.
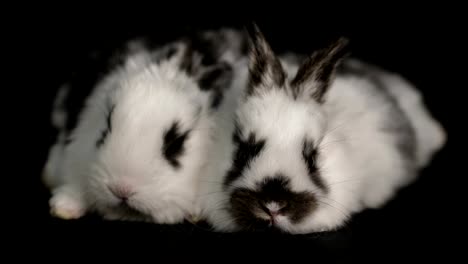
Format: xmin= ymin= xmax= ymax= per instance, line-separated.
xmin=229 ymin=174 xmax=317 ymax=231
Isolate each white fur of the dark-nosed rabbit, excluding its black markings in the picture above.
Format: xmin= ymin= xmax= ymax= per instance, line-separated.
xmin=200 ymin=56 xmax=445 ymax=233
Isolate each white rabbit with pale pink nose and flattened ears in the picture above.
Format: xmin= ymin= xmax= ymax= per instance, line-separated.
xmin=43 ymin=30 xmax=243 ymax=224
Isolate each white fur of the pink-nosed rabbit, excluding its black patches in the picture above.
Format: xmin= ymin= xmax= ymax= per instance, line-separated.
xmin=44 ymin=43 xmax=218 ymax=223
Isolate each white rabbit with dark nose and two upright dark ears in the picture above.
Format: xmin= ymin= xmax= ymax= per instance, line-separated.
xmin=199 ymin=25 xmax=446 ymax=234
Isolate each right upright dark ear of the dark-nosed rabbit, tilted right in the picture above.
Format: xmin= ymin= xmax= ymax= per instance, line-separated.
xmin=291 ymin=38 xmax=349 ymax=102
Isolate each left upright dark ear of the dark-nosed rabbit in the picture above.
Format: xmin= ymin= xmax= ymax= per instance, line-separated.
xmin=246 ymin=24 xmax=286 ymax=95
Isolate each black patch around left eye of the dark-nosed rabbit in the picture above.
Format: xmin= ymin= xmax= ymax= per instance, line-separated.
xmin=224 ymin=122 xmax=265 ymax=188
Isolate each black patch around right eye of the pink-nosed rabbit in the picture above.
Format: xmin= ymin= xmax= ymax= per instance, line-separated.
xmin=162 ymin=122 xmax=190 ymax=169
